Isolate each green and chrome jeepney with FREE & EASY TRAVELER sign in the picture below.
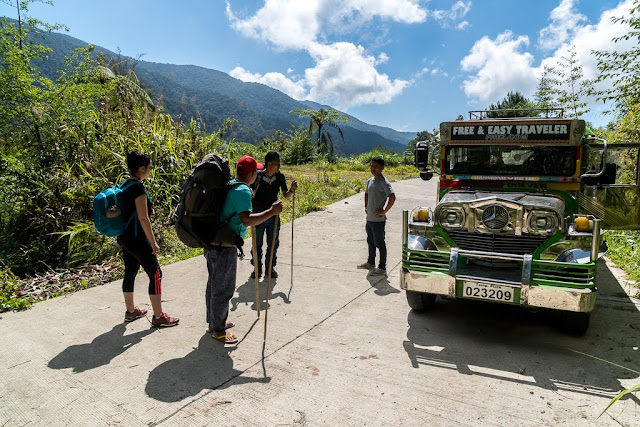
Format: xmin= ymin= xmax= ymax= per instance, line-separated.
xmin=401 ymin=111 xmax=640 ymax=335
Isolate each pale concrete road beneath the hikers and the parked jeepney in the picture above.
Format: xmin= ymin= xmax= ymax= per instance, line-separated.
xmin=0 ymin=179 xmax=640 ymax=426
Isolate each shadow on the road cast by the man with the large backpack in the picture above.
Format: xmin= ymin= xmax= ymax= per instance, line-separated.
xmin=145 ymin=334 xmax=271 ymax=402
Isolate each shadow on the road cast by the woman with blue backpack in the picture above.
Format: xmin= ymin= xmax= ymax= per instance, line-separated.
xmin=47 ymin=319 xmax=156 ymax=372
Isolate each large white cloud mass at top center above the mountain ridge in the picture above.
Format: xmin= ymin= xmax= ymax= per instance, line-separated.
xmin=226 ymin=0 xmax=430 ymax=109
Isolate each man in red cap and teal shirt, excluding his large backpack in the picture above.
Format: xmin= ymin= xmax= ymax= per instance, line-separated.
xmin=204 ymin=156 xmax=282 ymax=344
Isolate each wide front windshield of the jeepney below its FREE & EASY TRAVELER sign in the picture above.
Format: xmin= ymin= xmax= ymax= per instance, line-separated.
xmin=444 ymin=145 xmax=577 ymax=176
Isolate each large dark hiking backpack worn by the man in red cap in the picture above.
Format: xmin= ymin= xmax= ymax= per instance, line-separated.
xmin=175 ymin=154 xmax=246 ymax=248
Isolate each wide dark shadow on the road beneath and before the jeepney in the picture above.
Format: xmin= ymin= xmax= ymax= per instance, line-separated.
xmin=403 ymin=260 xmax=640 ymax=402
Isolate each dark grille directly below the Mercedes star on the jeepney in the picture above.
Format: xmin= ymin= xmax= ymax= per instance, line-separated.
xmin=447 ymin=231 xmax=547 ymax=255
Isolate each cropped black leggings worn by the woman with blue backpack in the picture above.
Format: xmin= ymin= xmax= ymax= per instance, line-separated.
xmin=118 ymin=236 xmax=162 ymax=295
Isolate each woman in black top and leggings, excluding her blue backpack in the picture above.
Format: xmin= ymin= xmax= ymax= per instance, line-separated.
xmin=118 ymin=151 xmax=179 ymax=327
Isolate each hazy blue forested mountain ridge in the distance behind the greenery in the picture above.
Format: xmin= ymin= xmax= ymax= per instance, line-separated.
xmin=22 ymin=23 xmax=416 ymax=155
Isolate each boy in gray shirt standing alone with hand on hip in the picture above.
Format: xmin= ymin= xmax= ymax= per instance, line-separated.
xmin=358 ymin=156 xmax=396 ymax=276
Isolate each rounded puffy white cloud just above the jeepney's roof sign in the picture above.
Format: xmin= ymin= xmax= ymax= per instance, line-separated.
xmin=461 ymin=31 xmax=539 ymax=103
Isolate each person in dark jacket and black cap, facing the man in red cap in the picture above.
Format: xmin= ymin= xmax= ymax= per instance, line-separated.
xmin=251 ymin=151 xmax=298 ymax=279
